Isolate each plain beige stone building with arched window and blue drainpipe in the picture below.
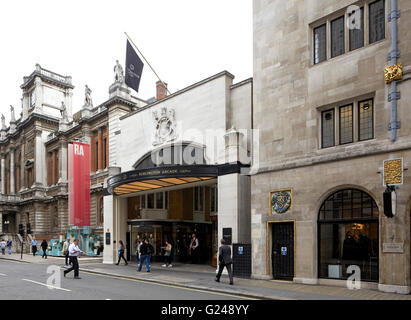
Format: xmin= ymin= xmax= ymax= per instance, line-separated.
xmin=251 ymin=0 xmax=411 ymax=293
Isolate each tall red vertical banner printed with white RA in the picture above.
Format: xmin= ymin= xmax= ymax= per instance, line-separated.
xmin=68 ymin=142 xmax=90 ymax=226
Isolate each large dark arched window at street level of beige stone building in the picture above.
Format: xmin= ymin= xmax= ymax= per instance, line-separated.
xmin=318 ymin=189 xmax=379 ymax=281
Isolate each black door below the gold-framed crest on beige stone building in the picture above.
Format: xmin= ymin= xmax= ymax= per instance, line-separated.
xmin=271 ymin=222 xmax=294 ymax=280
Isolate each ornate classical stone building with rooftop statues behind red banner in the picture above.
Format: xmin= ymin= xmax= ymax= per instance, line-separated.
xmin=0 ymin=65 xmax=145 ymax=252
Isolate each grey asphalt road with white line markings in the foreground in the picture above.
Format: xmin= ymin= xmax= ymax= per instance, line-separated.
xmin=0 ymin=260 xmax=243 ymax=300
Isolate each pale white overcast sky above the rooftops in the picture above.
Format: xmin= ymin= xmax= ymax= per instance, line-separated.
xmin=0 ymin=0 xmax=252 ymax=122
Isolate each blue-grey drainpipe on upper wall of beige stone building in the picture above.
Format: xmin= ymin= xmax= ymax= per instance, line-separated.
xmin=388 ymin=0 xmax=401 ymax=142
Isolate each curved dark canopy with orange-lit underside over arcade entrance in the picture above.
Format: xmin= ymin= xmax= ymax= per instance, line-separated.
xmin=107 ymin=165 xmax=218 ymax=196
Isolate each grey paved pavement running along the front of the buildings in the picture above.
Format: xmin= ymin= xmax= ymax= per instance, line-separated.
xmin=0 ymin=254 xmax=411 ymax=300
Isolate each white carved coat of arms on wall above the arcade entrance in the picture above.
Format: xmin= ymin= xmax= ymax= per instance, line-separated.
xmin=153 ymin=107 xmax=177 ymax=146
